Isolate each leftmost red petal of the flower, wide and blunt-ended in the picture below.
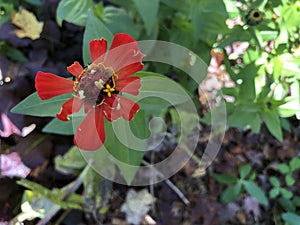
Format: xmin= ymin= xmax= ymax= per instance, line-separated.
xmin=35 ymin=72 xmax=74 ymax=100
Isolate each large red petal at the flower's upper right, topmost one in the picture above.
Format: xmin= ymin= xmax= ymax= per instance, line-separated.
xmin=105 ymin=34 xmax=144 ymax=71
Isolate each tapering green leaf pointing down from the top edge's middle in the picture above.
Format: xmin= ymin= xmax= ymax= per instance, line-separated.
xmin=134 ymin=0 xmax=159 ymax=35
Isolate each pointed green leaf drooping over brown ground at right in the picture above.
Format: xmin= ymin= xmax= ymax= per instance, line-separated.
xmin=260 ymin=111 xmax=283 ymax=141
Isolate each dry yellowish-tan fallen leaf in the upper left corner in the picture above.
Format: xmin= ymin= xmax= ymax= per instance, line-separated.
xmin=11 ymin=9 xmax=44 ymax=40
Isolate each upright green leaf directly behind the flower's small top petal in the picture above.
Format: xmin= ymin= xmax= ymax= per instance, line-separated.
xmin=82 ymin=10 xmax=113 ymax=65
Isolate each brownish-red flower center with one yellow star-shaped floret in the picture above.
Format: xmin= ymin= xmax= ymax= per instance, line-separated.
xmin=74 ymin=63 xmax=117 ymax=105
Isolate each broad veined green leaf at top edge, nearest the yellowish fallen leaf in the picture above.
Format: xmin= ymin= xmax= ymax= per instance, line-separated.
xmin=56 ymin=0 xmax=93 ymax=26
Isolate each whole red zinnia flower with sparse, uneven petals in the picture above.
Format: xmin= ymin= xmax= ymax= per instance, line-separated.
xmin=35 ymin=34 xmax=144 ymax=150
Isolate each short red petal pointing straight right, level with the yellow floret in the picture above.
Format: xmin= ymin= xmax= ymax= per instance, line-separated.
xmin=116 ymin=77 xmax=141 ymax=95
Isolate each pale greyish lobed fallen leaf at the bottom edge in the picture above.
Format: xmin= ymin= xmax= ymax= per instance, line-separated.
xmin=121 ymin=189 xmax=155 ymax=225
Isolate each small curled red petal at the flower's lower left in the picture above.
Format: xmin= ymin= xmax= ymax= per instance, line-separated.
xmin=56 ymin=97 xmax=83 ymax=121
